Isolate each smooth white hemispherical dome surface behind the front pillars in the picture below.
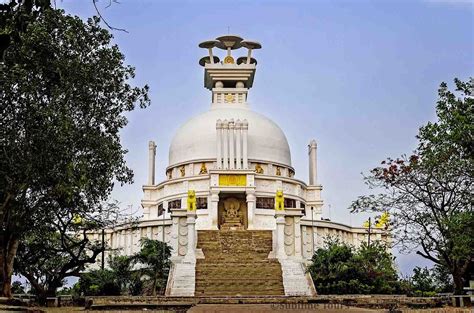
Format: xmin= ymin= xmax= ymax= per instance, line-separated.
xmin=169 ymin=106 xmax=291 ymax=166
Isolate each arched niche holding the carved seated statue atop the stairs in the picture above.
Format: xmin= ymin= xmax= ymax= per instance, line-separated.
xmin=219 ymin=198 xmax=246 ymax=230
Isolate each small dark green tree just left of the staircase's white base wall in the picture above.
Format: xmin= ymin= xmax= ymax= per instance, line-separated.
xmin=134 ymin=238 xmax=171 ymax=296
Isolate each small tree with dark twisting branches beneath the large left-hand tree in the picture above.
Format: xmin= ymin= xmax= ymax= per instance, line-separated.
xmin=14 ymin=204 xmax=126 ymax=302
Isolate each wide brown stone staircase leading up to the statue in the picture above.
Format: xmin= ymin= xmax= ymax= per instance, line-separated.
xmin=195 ymin=230 xmax=285 ymax=296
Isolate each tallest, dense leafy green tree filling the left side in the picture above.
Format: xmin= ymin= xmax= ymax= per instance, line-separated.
xmin=0 ymin=2 xmax=150 ymax=296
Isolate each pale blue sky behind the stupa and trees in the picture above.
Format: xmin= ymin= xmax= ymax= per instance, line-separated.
xmin=56 ymin=0 xmax=474 ymax=273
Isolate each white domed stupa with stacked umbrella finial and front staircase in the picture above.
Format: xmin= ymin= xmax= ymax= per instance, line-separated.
xmin=92 ymin=35 xmax=389 ymax=296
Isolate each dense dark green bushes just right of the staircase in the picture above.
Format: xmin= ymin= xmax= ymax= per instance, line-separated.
xmin=308 ymin=238 xmax=400 ymax=294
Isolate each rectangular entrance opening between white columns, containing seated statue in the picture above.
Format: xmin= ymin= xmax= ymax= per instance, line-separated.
xmin=218 ymin=194 xmax=248 ymax=230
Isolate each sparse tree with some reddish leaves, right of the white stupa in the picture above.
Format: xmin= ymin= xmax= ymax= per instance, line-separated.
xmin=351 ymin=79 xmax=474 ymax=293
